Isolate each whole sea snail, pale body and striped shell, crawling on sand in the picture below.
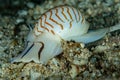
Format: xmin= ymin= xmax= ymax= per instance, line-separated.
xmin=11 ymin=6 xmax=120 ymax=64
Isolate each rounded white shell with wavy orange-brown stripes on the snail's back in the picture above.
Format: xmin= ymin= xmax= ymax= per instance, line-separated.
xmin=34 ymin=6 xmax=89 ymax=40
